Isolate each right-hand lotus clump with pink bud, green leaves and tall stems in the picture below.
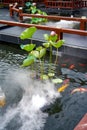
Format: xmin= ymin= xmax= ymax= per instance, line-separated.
xmin=43 ymin=31 xmax=64 ymax=77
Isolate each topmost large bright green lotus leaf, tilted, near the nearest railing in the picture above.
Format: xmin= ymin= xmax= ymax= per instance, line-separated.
xmin=20 ymin=27 xmax=37 ymax=40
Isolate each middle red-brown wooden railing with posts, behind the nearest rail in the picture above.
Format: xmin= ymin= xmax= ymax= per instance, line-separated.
xmin=9 ymin=5 xmax=87 ymax=30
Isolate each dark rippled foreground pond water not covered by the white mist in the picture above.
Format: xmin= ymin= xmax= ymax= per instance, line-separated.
xmin=0 ymin=43 xmax=87 ymax=130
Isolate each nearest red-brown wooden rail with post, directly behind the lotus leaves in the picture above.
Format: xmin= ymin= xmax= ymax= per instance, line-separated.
xmin=0 ymin=20 xmax=87 ymax=39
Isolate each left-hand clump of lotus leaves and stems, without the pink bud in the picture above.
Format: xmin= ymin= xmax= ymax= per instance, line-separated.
xmin=20 ymin=27 xmax=46 ymax=75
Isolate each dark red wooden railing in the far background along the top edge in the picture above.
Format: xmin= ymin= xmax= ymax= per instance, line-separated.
xmin=0 ymin=0 xmax=87 ymax=9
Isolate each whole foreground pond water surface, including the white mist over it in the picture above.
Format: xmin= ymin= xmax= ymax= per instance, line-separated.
xmin=0 ymin=43 xmax=87 ymax=130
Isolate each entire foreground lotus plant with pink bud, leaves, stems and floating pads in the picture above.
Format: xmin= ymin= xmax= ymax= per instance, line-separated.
xmin=20 ymin=27 xmax=64 ymax=83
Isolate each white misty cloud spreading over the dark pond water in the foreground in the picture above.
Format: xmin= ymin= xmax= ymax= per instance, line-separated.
xmin=0 ymin=70 xmax=61 ymax=130
